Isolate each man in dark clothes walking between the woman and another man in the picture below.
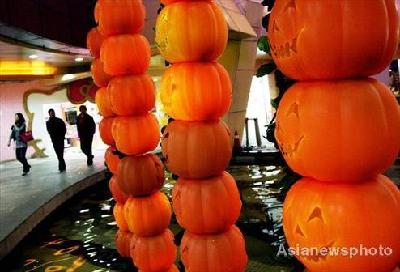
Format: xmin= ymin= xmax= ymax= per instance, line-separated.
xmin=46 ymin=109 xmax=67 ymax=172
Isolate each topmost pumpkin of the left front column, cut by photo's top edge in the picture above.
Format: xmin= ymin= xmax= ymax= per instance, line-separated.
xmin=96 ymin=0 xmax=146 ymax=36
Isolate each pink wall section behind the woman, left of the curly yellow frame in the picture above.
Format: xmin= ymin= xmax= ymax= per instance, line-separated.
xmin=0 ymin=81 xmax=49 ymax=161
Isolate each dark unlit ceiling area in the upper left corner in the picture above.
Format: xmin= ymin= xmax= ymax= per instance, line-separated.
xmin=0 ymin=0 xmax=96 ymax=47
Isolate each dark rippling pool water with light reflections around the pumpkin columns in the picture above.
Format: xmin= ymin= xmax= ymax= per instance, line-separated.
xmin=0 ymin=166 xmax=302 ymax=272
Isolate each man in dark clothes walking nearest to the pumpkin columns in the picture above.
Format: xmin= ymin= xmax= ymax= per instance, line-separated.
xmin=77 ymin=105 xmax=96 ymax=165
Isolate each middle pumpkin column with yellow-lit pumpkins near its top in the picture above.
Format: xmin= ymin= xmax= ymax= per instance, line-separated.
xmin=156 ymin=0 xmax=247 ymax=272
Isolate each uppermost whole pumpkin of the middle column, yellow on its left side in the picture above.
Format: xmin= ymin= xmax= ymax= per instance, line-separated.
xmin=155 ymin=1 xmax=228 ymax=63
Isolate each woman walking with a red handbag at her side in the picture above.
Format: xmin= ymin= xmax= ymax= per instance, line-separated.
xmin=8 ymin=112 xmax=31 ymax=176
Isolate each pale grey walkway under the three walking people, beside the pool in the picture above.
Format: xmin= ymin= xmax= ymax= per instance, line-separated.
xmin=0 ymin=150 xmax=105 ymax=244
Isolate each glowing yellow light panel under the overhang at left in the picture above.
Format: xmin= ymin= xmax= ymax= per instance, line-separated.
xmin=0 ymin=60 xmax=57 ymax=76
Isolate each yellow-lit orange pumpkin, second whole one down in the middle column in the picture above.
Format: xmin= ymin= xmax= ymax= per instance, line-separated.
xmin=160 ymin=62 xmax=232 ymax=121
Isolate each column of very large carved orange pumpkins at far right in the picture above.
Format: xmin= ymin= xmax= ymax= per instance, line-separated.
xmin=268 ymin=0 xmax=400 ymax=272
